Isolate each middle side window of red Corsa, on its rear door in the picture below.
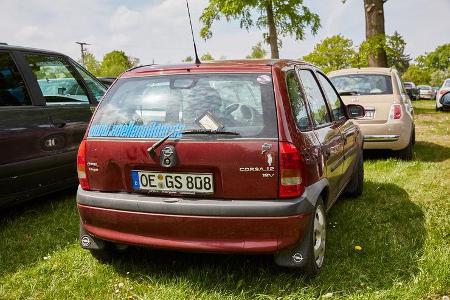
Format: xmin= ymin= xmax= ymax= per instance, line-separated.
xmin=299 ymin=70 xmax=331 ymax=126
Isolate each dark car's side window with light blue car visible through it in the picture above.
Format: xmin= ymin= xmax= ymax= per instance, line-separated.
xmin=27 ymin=55 xmax=89 ymax=105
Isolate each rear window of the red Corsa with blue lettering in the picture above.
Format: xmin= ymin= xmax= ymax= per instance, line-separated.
xmin=88 ymin=74 xmax=278 ymax=138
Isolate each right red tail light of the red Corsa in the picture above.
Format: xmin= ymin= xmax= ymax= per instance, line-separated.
xmin=279 ymin=142 xmax=305 ymax=198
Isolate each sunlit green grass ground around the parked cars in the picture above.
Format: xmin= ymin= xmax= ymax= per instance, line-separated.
xmin=0 ymin=101 xmax=450 ymax=299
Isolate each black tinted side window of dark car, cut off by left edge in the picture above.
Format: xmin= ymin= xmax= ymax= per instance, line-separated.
xmin=0 ymin=52 xmax=31 ymax=107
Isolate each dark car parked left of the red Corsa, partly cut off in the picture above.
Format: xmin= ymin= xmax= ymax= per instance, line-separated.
xmin=0 ymin=45 xmax=106 ymax=207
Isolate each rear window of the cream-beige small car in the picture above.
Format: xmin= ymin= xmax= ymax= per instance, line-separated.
xmin=330 ymin=74 xmax=392 ymax=95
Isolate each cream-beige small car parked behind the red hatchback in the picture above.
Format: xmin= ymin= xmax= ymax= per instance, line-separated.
xmin=329 ymin=68 xmax=415 ymax=160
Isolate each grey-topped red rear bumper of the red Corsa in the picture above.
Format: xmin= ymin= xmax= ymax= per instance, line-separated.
xmin=77 ymin=188 xmax=314 ymax=253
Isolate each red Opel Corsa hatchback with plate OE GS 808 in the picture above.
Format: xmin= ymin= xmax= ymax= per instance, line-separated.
xmin=77 ymin=60 xmax=364 ymax=274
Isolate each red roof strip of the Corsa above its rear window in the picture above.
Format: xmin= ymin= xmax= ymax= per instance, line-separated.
xmin=120 ymin=59 xmax=314 ymax=78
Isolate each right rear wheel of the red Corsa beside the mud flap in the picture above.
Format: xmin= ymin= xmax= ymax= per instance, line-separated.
xmin=301 ymin=197 xmax=327 ymax=277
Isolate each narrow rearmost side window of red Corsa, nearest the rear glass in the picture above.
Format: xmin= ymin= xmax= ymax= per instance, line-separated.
xmin=286 ymin=71 xmax=311 ymax=131
